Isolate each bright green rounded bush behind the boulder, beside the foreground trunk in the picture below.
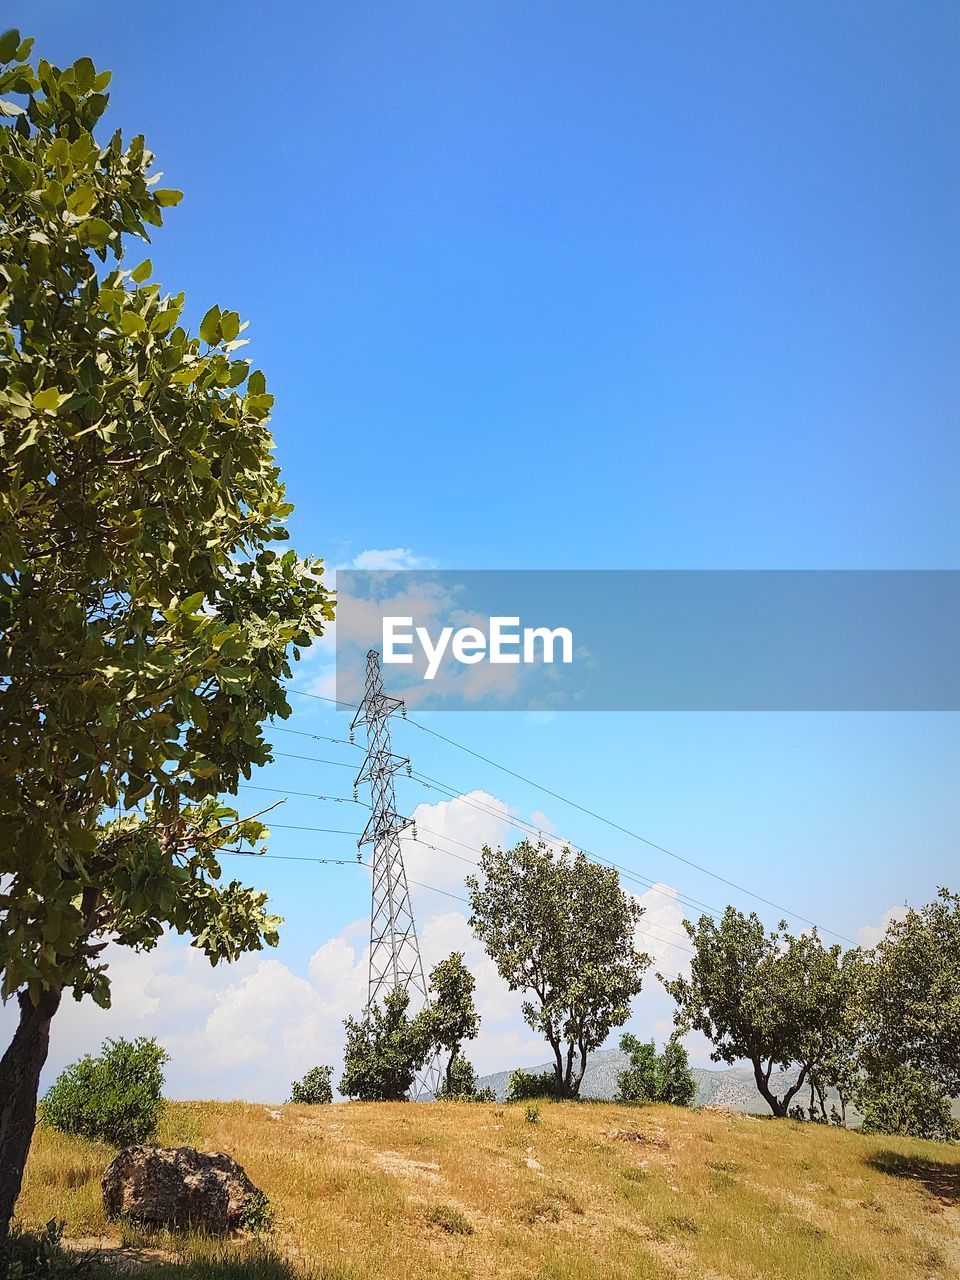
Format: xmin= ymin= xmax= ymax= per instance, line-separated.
xmin=40 ymin=1036 xmax=169 ymax=1147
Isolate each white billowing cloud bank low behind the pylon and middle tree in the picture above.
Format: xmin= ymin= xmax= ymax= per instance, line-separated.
xmin=0 ymin=791 xmax=706 ymax=1101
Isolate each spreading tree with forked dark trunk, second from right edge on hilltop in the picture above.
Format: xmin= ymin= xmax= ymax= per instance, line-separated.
xmin=662 ymin=906 xmax=846 ymax=1116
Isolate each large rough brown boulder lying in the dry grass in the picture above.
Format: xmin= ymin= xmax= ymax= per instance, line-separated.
xmin=102 ymin=1146 xmax=266 ymax=1235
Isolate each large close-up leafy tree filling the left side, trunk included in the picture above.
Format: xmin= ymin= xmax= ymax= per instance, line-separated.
xmin=0 ymin=32 xmax=333 ymax=1238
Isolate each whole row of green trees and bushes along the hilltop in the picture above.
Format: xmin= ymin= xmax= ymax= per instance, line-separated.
xmin=340 ymin=841 xmax=960 ymax=1138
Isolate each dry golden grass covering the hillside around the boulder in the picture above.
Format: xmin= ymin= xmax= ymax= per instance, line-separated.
xmin=18 ymin=1102 xmax=960 ymax=1280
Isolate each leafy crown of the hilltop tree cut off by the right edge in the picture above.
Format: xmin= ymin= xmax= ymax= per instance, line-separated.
xmin=863 ymin=888 xmax=960 ymax=1097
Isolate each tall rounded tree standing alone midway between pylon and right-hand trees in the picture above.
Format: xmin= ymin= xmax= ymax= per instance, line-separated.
xmin=466 ymin=840 xmax=650 ymax=1098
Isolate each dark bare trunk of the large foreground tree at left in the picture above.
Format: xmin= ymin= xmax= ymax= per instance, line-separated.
xmin=0 ymin=989 xmax=60 ymax=1243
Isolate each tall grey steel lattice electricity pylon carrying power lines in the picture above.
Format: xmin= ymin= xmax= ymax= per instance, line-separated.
xmin=351 ymin=649 xmax=440 ymax=1096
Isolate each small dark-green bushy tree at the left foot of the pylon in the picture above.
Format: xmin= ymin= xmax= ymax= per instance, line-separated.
xmin=340 ymin=987 xmax=430 ymax=1102
